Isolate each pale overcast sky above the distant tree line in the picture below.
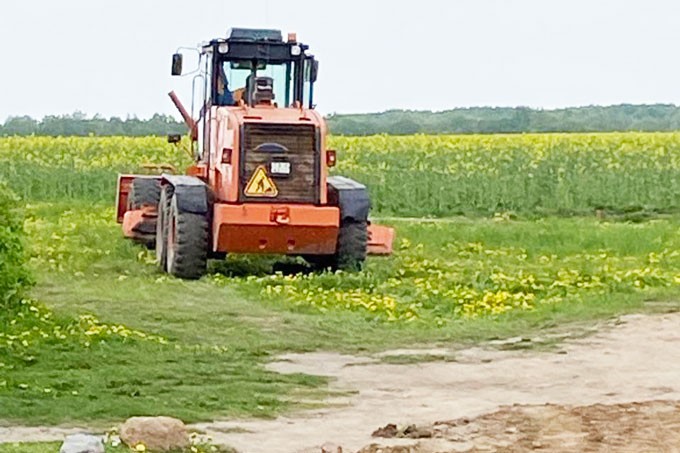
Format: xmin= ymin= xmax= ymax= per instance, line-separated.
xmin=0 ymin=0 xmax=680 ymax=121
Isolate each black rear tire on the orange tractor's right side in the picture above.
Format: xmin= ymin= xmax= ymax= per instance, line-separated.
xmin=304 ymin=220 xmax=368 ymax=272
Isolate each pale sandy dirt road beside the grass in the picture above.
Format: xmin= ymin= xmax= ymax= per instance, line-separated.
xmin=199 ymin=314 xmax=680 ymax=453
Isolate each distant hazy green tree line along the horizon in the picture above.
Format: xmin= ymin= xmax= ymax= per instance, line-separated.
xmin=0 ymin=104 xmax=680 ymax=136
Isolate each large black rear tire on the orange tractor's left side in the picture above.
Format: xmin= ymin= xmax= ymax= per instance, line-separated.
xmin=166 ymin=196 xmax=208 ymax=280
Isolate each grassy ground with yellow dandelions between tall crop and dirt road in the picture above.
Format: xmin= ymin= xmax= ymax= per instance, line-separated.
xmin=0 ymin=204 xmax=680 ymax=428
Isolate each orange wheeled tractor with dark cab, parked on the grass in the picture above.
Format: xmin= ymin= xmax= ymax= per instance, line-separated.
xmin=117 ymin=29 xmax=394 ymax=279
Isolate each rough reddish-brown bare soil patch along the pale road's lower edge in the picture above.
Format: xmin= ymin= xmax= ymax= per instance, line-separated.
xmin=360 ymin=401 xmax=680 ymax=453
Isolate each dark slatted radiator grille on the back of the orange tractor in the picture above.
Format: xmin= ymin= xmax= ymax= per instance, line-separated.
xmin=240 ymin=123 xmax=319 ymax=203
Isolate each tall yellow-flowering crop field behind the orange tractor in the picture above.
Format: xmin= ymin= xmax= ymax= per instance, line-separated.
xmin=0 ymin=133 xmax=680 ymax=217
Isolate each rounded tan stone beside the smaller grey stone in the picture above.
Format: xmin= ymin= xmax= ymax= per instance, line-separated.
xmin=119 ymin=417 xmax=191 ymax=452
